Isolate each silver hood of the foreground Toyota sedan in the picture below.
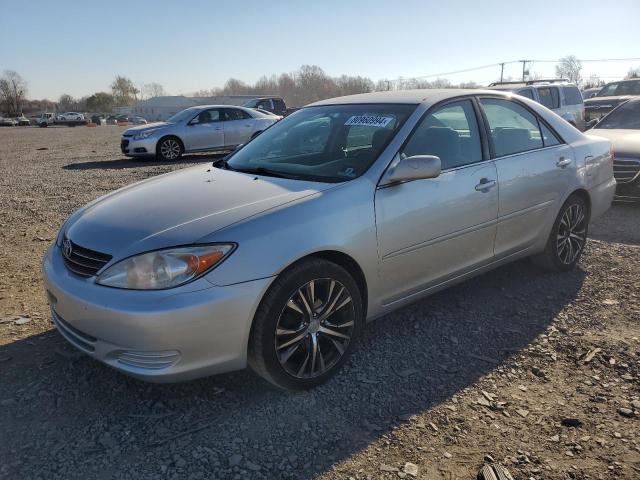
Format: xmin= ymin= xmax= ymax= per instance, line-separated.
xmin=64 ymin=165 xmax=335 ymax=259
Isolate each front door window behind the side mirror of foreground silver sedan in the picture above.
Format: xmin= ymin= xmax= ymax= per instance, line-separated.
xmin=401 ymin=100 xmax=482 ymax=170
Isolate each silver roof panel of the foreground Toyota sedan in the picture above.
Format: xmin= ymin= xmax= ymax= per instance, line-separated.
xmin=309 ymin=88 xmax=508 ymax=107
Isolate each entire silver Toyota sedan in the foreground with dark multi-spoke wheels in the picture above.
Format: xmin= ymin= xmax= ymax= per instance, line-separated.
xmin=44 ymin=90 xmax=616 ymax=389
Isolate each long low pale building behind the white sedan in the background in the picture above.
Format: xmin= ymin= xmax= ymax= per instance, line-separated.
xmin=130 ymin=95 xmax=260 ymax=121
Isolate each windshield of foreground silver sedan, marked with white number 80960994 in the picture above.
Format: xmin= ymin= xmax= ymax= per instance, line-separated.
xmin=228 ymin=105 xmax=415 ymax=182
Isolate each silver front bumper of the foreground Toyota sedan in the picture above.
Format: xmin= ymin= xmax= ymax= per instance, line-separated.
xmin=43 ymin=246 xmax=272 ymax=382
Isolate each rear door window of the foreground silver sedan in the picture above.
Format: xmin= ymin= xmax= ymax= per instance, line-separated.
xmin=480 ymin=98 xmax=544 ymax=157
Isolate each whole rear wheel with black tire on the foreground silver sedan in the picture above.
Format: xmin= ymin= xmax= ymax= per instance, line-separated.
xmin=533 ymin=194 xmax=589 ymax=272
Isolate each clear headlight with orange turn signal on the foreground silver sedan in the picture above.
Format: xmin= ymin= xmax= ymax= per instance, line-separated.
xmin=96 ymin=243 xmax=235 ymax=290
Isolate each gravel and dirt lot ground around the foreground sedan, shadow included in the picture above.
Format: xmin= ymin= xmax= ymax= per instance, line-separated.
xmin=0 ymin=127 xmax=640 ymax=479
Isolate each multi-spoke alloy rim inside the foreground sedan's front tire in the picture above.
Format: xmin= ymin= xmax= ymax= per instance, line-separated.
xmin=275 ymin=278 xmax=355 ymax=378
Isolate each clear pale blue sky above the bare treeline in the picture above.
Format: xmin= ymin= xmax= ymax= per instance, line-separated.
xmin=0 ymin=0 xmax=640 ymax=99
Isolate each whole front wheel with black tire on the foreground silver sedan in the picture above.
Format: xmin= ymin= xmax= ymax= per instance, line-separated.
xmin=248 ymin=259 xmax=364 ymax=390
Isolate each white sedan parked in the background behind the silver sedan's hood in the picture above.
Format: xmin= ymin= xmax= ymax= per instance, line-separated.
xmin=120 ymin=105 xmax=280 ymax=160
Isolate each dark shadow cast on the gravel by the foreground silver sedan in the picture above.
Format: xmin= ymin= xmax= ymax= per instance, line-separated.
xmin=0 ymin=261 xmax=585 ymax=479
